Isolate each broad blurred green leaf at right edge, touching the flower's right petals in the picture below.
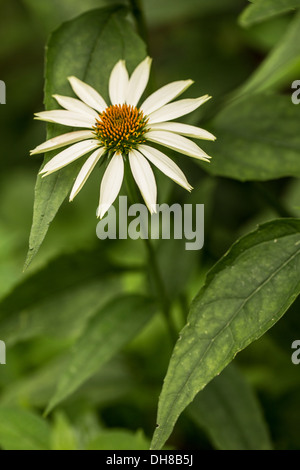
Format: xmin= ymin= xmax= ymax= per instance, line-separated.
xmin=202 ymin=94 xmax=300 ymax=181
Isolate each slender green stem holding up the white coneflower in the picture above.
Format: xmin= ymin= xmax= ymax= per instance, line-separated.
xmin=125 ymin=165 xmax=178 ymax=344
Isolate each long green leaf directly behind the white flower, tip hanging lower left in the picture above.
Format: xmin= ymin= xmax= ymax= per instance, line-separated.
xmin=25 ymin=6 xmax=146 ymax=268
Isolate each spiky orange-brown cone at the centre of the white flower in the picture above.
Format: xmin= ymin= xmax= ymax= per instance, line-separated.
xmin=94 ymin=104 xmax=147 ymax=153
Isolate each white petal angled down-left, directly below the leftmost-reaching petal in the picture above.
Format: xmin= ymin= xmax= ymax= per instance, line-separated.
xmin=40 ymin=139 xmax=99 ymax=176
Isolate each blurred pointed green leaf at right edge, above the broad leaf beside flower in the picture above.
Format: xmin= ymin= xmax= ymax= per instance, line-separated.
xmin=236 ymin=13 xmax=300 ymax=96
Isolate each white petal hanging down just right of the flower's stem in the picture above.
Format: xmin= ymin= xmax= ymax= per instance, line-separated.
xmin=129 ymin=150 xmax=157 ymax=214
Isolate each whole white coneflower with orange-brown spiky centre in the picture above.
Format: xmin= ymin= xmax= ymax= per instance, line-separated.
xmin=31 ymin=57 xmax=215 ymax=218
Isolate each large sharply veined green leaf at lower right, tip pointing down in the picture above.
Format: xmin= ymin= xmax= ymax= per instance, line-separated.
xmin=152 ymin=219 xmax=300 ymax=449
